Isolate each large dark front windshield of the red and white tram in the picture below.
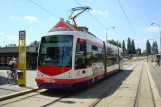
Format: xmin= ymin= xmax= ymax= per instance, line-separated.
xmin=38 ymin=35 xmax=73 ymax=67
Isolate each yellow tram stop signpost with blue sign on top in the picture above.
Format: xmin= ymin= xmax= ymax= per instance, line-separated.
xmin=18 ymin=30 xmax=26 ymax=86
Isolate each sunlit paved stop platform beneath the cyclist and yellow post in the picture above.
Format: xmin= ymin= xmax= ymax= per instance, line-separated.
xmin=0 ymin=70 xmax=38 ymax=101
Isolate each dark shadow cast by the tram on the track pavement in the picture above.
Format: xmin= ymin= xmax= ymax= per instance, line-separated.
xmin=40 ymin=70 xmax=132 ymax=105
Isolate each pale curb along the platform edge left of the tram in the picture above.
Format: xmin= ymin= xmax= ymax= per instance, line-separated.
xmin=0 ymin=87 xmax=40 ymax=101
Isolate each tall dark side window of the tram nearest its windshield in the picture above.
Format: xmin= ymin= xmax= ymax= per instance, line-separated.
xmin=75 ymin=41 xmax=86 ymax=69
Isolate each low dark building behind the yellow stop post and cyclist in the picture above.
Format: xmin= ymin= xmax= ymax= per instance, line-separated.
xmin=0 ymin=42 xmax=39 ymax=69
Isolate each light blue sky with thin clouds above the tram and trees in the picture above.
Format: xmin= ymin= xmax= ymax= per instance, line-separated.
xmin=0 ymin=0 xmax=161 ymax=51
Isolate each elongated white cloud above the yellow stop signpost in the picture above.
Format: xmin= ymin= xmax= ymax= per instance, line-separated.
xmin=9 ymin=16 xmax=38 ymax=23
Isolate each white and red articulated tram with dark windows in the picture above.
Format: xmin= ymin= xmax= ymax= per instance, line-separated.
xmin=35 ymin=30 xmax=123 ymax=90
